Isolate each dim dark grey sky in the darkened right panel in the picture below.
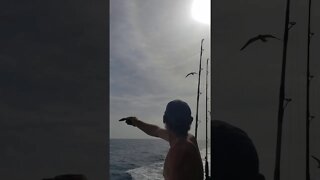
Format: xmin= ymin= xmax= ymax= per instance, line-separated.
xmin=211 ymin=0 xmax=320 ymax=180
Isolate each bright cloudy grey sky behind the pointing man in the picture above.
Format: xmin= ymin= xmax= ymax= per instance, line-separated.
xmin=110 ymin=0 xmax=210 ymax=139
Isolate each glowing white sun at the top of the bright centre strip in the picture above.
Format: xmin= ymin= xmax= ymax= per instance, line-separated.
xmin=191 ymin=0 xmax=210 ymax=24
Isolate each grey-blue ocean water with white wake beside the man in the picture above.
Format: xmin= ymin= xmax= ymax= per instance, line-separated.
xmin=110 ymin=139 xmax=210 ymax=180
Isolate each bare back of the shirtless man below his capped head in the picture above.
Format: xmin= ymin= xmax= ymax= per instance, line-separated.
xmin=163 ymin=135 xmax=203 ymax=180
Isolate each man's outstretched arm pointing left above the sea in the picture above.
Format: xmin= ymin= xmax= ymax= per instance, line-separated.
xmin=119 ymin=117 xmax=169 ymax=141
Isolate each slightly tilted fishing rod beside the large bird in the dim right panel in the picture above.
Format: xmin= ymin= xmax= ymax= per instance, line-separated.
xmin=274 ymin=0 xmax=290 ymax=180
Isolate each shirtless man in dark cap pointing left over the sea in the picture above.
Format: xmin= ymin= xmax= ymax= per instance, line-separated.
xmin=120 ymin=100 xmax=203 ymax=180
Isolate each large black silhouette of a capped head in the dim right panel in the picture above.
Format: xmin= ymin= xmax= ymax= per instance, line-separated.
xmin=211 ymin=120 xmax=265 ymax=180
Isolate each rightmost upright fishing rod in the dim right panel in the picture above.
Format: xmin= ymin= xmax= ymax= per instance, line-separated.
xmin=306 ymin=0 xmax=313 ymax=180
